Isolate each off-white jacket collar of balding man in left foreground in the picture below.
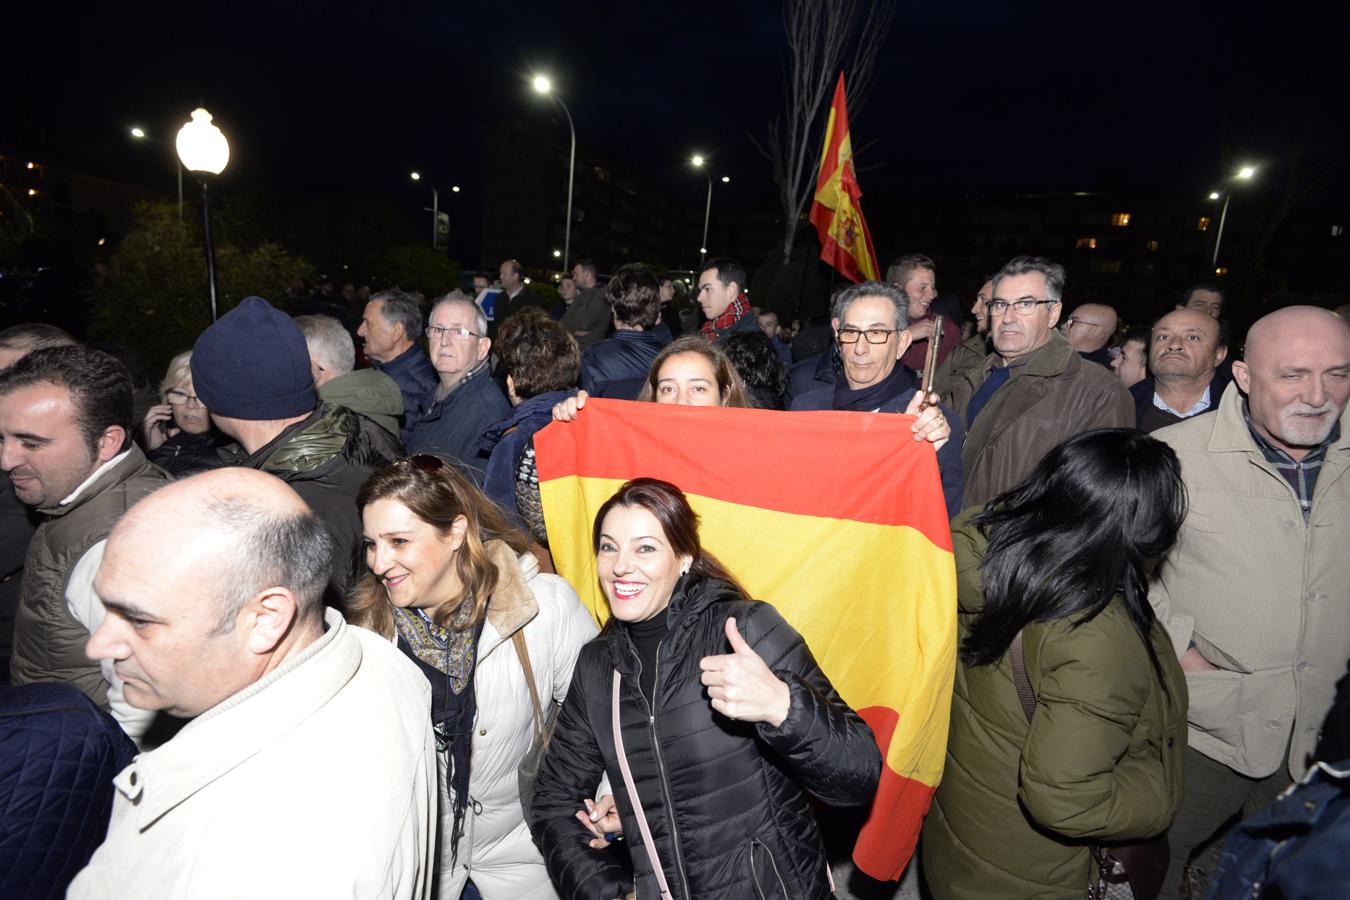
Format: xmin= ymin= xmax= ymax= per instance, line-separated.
xmin=112 ymin=609 xmax=362 ymax=831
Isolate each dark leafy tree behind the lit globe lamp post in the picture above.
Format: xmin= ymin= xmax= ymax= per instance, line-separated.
xmin=89 ymin=202 xmax=313 ymax=372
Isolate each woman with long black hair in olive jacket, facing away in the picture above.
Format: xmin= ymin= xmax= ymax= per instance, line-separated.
xmin=923 ymin=429 xmax=1187 ymax=900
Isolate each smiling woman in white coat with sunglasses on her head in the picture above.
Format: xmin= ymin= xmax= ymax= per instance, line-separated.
xmin=348 ymin=456 xmax=595 ymax=900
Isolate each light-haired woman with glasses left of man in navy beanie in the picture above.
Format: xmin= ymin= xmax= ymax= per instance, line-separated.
xmin=142 ymin=349 xmax=230 ymax=478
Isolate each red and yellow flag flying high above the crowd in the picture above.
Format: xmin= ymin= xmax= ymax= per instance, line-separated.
xmin=811 ymin=72 xmax=880 ymax=282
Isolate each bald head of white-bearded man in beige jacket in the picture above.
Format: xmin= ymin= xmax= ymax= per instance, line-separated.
xmin=1233 ymin=306 xmax=1350 ymax=459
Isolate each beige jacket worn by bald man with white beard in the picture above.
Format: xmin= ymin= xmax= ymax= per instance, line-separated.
xmin=1149 ymin=385 xmax=1350 ymax=779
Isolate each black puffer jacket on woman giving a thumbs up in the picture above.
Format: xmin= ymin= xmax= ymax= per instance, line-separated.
xmin=531 ymin=576 xmax=882 ymax=900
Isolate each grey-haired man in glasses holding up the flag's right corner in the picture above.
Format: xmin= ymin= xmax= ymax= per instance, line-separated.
xmin=792 ymin=281 xmax=964 ymax=515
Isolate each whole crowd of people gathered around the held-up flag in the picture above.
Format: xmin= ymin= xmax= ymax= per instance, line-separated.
xmin=0 ymin=248 xmax=1350 ymax=900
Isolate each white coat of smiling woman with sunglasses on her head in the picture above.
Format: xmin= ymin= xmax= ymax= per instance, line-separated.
xmin=437 ymin=545 xmax=598 ymax=900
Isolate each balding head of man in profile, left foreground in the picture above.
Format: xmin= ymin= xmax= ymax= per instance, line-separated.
xmin=86 ymin=468 xmax=336 ymax=716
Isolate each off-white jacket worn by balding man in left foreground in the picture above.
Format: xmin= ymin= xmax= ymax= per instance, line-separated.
xmin=66 ymin=610 xmax=436 ymax=900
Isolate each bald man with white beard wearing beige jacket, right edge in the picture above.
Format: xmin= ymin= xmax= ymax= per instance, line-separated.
xmin=1149 ymin=306 xmax=1350 ymax=897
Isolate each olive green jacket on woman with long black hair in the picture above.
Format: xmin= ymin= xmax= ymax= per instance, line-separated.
xmin=923 ymin=510 xmax=1187 ymax=900
